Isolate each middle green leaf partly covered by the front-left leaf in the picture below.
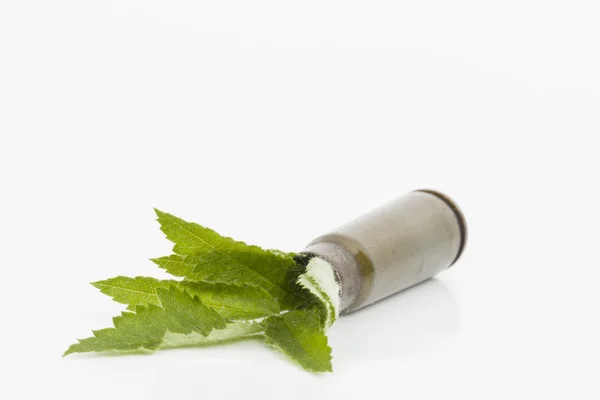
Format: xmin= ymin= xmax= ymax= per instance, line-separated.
xmin=92 ymin=276 xmax=280 ymax=320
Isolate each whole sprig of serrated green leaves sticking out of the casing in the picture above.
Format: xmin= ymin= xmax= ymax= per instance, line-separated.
xmin=64 ymin=210 xmax=336 ymax=372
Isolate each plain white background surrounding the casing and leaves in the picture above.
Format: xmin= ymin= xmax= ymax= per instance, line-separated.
xmin=0 ymin=0 xmax=600 ymax=399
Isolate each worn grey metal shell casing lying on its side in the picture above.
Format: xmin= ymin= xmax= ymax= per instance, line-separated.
xmin=304 ymin=190 xmax=467 ymax=313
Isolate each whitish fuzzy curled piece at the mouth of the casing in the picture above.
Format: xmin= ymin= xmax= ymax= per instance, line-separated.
xmin=298 ymin=257 xmax=341 ymax=327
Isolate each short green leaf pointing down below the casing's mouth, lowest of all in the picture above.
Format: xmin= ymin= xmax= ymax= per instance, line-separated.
xmin=262 ymin=308 xmax=332 ymax=372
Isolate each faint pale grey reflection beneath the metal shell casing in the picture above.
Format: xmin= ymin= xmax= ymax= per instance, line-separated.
xmin=329 ymin=278 xmax=460 ymax=365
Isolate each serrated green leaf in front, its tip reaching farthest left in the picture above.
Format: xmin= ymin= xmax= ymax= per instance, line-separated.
xmin=64 ymin=287 xmax=226 ymax=355
